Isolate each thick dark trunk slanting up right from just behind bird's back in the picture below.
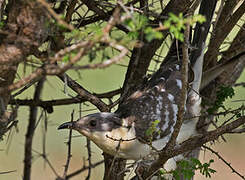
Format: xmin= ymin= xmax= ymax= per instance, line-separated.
xmin=122 ymin=0 xmax=198 ymax=98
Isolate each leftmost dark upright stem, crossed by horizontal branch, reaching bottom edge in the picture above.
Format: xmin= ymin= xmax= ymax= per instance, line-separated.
xmin=23 ymin=78 xmax=45 ymax=180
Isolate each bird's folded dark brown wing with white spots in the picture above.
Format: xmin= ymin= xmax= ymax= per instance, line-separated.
xmin=116 ymin=61 xmax=182 ymax=143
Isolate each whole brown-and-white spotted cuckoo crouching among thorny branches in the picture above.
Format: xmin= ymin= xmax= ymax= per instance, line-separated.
xmin=58 ymin=45 xmax=239 ymax=170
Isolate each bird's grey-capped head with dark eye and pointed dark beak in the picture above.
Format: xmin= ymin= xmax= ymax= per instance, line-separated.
xmin=58 ymin=112 xmax=121 ymax=141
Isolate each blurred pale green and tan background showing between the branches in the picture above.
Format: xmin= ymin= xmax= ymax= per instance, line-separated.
xmin=0 ymin=56 xmax=245 ymax=180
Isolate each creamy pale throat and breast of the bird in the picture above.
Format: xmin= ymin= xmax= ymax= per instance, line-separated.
xmin=82 ymin=121 xmax=172 ymax=160
